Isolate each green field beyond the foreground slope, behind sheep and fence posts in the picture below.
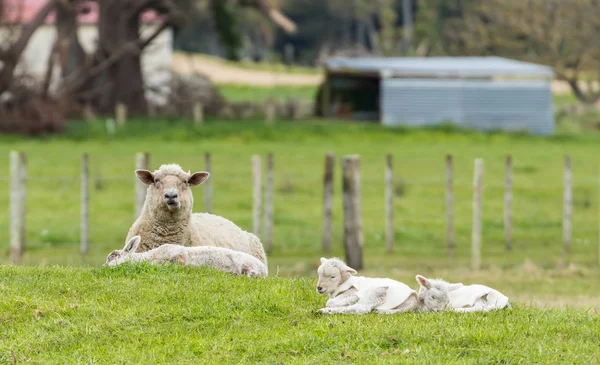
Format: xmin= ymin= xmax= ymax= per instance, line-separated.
xmin=0 ymin=121 xmax=600 ymax=308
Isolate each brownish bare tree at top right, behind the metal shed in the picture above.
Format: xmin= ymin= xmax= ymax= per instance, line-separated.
xmin=441 ymin=0 xmax=600 ymax=104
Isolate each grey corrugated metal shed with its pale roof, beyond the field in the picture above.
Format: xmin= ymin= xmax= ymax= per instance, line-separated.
xmin=326 ymin=57 xmax=554 ymax=135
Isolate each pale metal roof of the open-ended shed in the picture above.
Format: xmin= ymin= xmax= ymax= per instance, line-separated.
xmin=325 ymin=57 xmax=554 ymax=78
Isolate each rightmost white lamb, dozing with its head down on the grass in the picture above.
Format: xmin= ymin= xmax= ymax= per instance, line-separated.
xmin=416 ymin=275 xmax=511 ymax=312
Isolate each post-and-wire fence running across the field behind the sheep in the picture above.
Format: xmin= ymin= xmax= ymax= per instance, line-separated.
xmin=0 ymin=152 xmax=600 ymax=268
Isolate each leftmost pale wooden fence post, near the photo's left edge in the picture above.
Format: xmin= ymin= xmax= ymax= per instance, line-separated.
xmin=10 ymin=151 xmax=27 ymax=265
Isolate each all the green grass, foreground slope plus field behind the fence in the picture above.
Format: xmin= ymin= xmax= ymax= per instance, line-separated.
xmin=0 ymin=120 xmax=600 ymax=364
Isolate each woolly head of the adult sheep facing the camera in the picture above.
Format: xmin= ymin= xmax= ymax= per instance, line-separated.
xmin=135 ymin=164 xmax=209 ymax=212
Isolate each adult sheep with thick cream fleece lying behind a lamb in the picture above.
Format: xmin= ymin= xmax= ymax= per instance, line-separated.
xmin=125 ymin=164 xmax=267 ymax=265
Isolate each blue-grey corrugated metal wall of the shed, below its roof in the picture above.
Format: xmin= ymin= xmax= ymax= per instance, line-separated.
xmin=381 ymin=78 xmax=554 ymax=135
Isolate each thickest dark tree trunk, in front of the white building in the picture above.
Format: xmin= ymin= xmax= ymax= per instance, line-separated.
xmin=98 ymin=0 xmax=148 ymax=115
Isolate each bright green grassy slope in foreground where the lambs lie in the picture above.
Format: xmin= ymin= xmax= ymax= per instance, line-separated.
xmin=0 ymin=265 xmax=600 ymax=364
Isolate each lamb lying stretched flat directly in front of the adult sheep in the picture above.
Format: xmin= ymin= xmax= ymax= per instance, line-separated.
xmin=105 ymin=236 xmax=268 ymax=277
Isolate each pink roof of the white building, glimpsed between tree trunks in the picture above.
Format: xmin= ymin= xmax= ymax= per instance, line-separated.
xmin=0 ymin=0 xmax=161 ymax=24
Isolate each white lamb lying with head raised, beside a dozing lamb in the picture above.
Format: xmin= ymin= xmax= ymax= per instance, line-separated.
xmin=317 ymin=257 xmax=418 ymax=314
